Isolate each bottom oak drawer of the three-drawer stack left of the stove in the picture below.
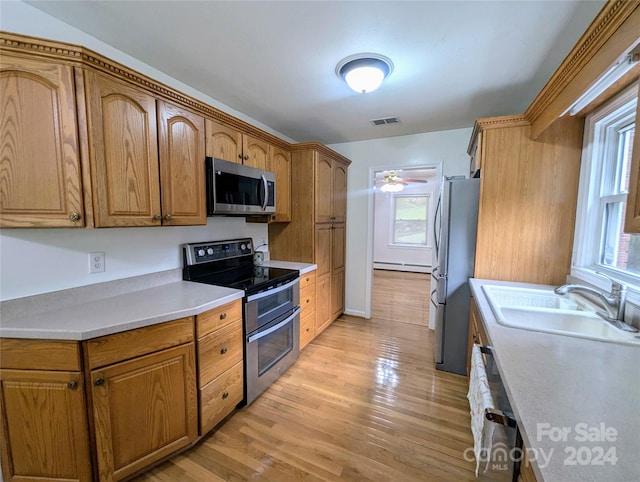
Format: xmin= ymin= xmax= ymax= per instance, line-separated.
xmin=200 ymin=362 xmax=244 ymax=435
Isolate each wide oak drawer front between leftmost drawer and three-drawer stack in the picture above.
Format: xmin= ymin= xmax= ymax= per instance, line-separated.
xmin=86 ymin=316 xmax=193 ymax=369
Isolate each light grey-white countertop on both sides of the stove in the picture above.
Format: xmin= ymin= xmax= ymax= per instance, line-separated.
xmin=0 ymin=260 xmax=317 ymax=340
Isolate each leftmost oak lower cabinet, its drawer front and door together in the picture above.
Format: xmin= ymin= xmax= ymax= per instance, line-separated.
xmin=0 ymin=338 xmax=92 ymax=482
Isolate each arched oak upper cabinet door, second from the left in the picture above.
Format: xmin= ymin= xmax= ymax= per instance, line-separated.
xmin=85 ymin=72 xmax=161 ymax=227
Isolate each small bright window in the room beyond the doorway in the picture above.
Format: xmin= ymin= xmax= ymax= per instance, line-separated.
xmin=391 ymin=194 xmax=429 ymax=246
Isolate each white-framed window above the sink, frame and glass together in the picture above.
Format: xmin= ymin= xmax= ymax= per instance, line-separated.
xmin=572 ymin=85 xmax=640 ymax=289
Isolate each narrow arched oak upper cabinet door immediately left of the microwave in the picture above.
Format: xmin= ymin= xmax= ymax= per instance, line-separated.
xmin=158 ymin=101 xmax=207 ymax=226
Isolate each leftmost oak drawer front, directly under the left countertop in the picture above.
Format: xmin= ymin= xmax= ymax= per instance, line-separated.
xmin=0 ymin=338 xmax=82 ymax=371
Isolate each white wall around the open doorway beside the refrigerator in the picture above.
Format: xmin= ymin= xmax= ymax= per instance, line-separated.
xmin=329 ymin=128 xmax=471 ymax=316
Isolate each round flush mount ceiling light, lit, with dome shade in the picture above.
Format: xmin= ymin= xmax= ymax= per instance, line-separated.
xmin=336 ymin=54 xmax=393 ymax=94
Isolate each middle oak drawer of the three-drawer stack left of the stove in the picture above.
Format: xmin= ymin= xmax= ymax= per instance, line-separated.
xmin=198 ymin=321 xmax=242 ymax=387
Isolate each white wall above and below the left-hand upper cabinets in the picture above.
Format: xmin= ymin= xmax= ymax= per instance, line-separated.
xmin=0 ymin=1 xmax=292 ymax=300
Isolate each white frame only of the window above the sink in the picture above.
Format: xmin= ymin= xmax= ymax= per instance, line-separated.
xmin=571 ymin=82 xmax=640 ymax=303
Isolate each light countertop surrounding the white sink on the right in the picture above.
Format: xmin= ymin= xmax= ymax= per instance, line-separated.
xmin=470 ymin=279 xmax=640 ymax=482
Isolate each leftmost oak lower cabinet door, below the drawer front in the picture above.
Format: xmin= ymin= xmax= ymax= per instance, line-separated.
xmin=0 ymin=370 xmax=92 ymax=482
